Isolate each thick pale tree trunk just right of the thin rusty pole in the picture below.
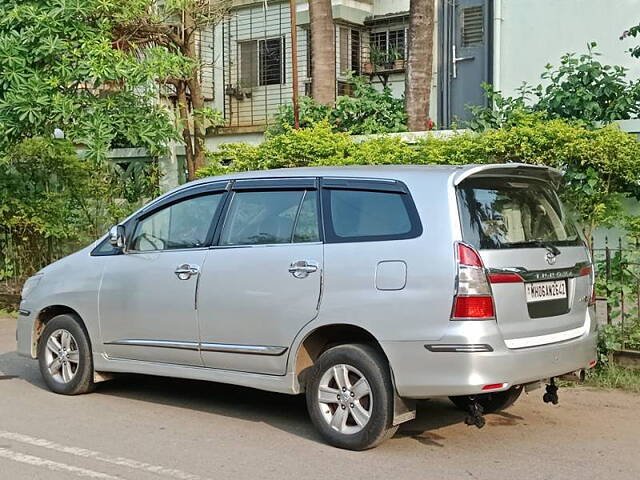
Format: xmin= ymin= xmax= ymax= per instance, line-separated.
xmin=309 ymin=0 xmax=336 ymax=105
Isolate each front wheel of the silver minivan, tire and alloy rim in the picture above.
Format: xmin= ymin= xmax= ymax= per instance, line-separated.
xmin=38 ymin=314 xmax=93 ymax=395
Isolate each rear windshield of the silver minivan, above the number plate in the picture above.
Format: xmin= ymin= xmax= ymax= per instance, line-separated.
xmin=458 ymin=178 xmax=581 ymax=249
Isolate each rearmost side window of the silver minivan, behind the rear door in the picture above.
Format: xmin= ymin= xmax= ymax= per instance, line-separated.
xmin=323 ymin=189 xmax=421 ymax=243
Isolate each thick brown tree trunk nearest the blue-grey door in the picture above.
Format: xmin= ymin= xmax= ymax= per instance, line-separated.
xmin=405 ymin=0 xmax=434 ymax=132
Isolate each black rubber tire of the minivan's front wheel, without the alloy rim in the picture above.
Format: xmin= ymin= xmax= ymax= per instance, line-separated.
xmin=38 ymin=314 xmax=94 ymax=395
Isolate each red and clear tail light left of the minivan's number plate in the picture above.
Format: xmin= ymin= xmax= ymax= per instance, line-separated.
xmin=451 ymin=243 xmax=495 ymax=320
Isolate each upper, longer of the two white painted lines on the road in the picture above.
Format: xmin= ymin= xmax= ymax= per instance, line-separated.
xmin=0 ymin=430 xmax=206 ymax=480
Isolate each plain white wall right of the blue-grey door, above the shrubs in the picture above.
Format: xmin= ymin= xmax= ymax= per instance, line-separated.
xmin=494 ymin=0 xmax=640 ymax=95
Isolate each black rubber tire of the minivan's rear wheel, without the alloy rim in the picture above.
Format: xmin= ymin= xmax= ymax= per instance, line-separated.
xmin=306 ymin=344 xmax=398 ymax=450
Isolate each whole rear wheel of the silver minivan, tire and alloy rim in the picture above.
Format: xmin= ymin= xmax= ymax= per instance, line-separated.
xmin=307 ymin=344 xmax=397 ymax=450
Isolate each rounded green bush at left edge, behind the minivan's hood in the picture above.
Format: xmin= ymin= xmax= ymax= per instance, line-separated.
xmin=0 ymin=137 xmax=94 ymax=282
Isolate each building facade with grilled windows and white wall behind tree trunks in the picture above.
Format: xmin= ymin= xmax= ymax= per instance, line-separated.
xmin=202 ymin=0 xmax=640 ymax=147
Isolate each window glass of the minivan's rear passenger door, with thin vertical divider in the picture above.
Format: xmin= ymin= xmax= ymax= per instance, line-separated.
xmin=220 ymin=190 xmax=319 ymax=246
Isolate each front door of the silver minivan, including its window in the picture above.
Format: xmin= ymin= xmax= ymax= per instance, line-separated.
xmin=99 ymin=189 xmax=225 ymax=365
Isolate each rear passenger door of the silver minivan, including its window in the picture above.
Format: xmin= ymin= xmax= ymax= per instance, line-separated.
xmin=198 ymin=179 xmax=323 ymax=375
